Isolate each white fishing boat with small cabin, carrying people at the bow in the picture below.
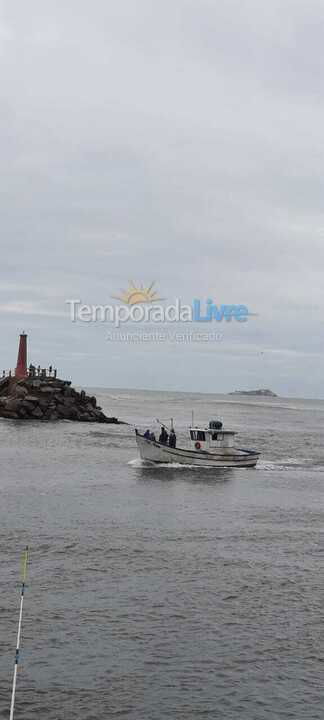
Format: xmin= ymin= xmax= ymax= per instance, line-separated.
xmin=135 ymin=420 xmax=260 ymax=468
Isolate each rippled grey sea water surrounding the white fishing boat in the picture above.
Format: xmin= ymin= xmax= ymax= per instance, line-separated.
xmin=0 ymin=391 xmax=324 ymax=720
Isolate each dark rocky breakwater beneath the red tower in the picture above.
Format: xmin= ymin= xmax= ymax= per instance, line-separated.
xmin=0 ymin=377 xmax=119 ymax=423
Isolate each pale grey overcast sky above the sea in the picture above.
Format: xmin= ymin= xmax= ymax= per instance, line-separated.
xmin=0 ymin=0 xmax=324 ymax=398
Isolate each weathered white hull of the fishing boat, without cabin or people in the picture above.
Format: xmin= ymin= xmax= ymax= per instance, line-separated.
xmin=136 ymin=433 xmax=259 ymax=468
